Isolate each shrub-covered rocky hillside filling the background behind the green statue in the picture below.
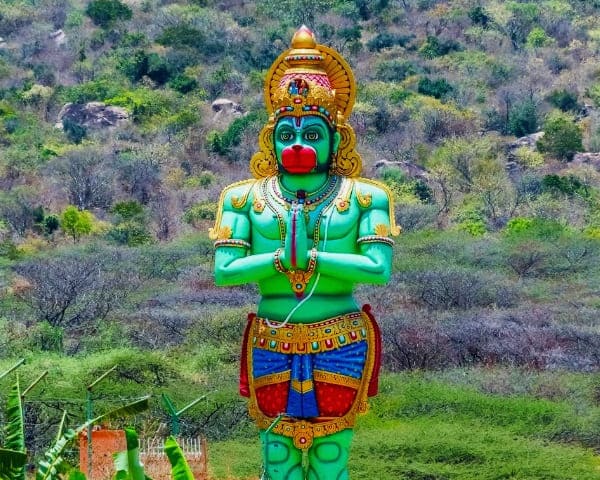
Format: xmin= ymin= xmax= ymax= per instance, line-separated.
xmin=0 ymin=0 xmax=600 ymax=480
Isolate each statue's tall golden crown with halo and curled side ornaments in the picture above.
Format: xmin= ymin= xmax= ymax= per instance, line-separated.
xmin=250 ymin=25 xmax=362 ymax=178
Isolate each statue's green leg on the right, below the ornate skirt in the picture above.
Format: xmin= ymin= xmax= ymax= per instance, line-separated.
xmin=308 ymin=428 xmax=354 ymax=480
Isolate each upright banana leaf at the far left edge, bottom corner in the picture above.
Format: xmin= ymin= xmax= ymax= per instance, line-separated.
xmin=0 ymin=376 xmax=26 ymax=480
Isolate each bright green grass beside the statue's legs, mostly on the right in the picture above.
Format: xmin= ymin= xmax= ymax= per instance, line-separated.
xmin=209 ymin=373 xmax=600 ymax=480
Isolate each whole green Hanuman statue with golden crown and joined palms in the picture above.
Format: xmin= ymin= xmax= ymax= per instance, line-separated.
xmin=210 ymin=27 xmax=399 ymax=480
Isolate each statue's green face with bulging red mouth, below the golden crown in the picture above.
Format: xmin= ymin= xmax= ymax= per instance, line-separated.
xmin=273 ymin=115 xmax=340 ymax=175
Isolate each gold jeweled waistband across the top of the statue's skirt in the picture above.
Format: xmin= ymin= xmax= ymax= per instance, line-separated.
xmin=250 ymin=312 xmax=368 ymax=354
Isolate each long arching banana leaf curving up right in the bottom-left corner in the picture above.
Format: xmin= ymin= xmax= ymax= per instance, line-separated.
xmin=35 ymin=397 xmax=150 ymax=480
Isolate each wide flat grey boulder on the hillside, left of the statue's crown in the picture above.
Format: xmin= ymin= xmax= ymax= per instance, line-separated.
xmin=55 ymin=102 xmax=129 ymax=128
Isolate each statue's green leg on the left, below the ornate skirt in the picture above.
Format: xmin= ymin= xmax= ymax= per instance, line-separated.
xmin=260 ymin=431 xmax=304 ymax=480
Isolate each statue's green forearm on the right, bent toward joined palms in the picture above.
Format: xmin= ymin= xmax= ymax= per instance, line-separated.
xmin=317 ymin=246 xmax=391 ymax=284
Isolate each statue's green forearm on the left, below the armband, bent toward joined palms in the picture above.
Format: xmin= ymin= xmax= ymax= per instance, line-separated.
xmin=215 ymin=249 xmax=276 ymax=287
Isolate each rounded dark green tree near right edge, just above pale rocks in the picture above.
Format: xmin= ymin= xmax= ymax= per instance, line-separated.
xmin=537 ymin=110 xmax=583 ymax=162
